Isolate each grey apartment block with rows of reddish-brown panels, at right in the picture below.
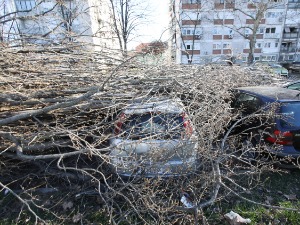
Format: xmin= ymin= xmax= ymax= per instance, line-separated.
xmin=170 ymin=0 xmax=300 ymax=64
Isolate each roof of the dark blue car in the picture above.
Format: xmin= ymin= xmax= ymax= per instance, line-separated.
xmin=236 ymin=86 xmax=300 ymax=101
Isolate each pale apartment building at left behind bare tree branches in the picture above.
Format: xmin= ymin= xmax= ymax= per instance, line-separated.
xmin=1 ymin=0 xmax=116 ymax=49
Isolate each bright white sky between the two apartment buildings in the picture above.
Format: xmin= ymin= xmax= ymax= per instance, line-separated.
xmin=129 ymin=0 xmax=169 ymax=49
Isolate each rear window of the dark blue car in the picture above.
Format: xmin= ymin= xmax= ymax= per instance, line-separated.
xmin=280 ymin=102 xmax=300 ymax=128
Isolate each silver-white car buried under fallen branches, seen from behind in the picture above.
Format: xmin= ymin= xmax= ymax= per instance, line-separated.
xmin=109 ymin=98 xmax=198 ymax=177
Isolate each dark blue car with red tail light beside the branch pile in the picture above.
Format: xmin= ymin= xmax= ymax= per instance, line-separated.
xmin=232 ymin=86 xmax=300 ymax=158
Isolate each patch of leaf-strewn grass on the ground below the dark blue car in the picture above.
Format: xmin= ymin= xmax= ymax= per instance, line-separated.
xmin=205 ymin=170 xmax=300 ymax=225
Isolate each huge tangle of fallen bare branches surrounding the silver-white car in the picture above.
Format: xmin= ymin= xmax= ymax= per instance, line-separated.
xmin=0 ymin=45 xmax=290 ymax=223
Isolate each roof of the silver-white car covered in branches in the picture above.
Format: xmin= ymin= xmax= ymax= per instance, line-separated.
xmin=123 ymin=98 xmax=184 ymax=114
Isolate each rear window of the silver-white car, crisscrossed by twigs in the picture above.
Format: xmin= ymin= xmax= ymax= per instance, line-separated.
xmin=122 ymin=113 xmax=184 ymax=139
